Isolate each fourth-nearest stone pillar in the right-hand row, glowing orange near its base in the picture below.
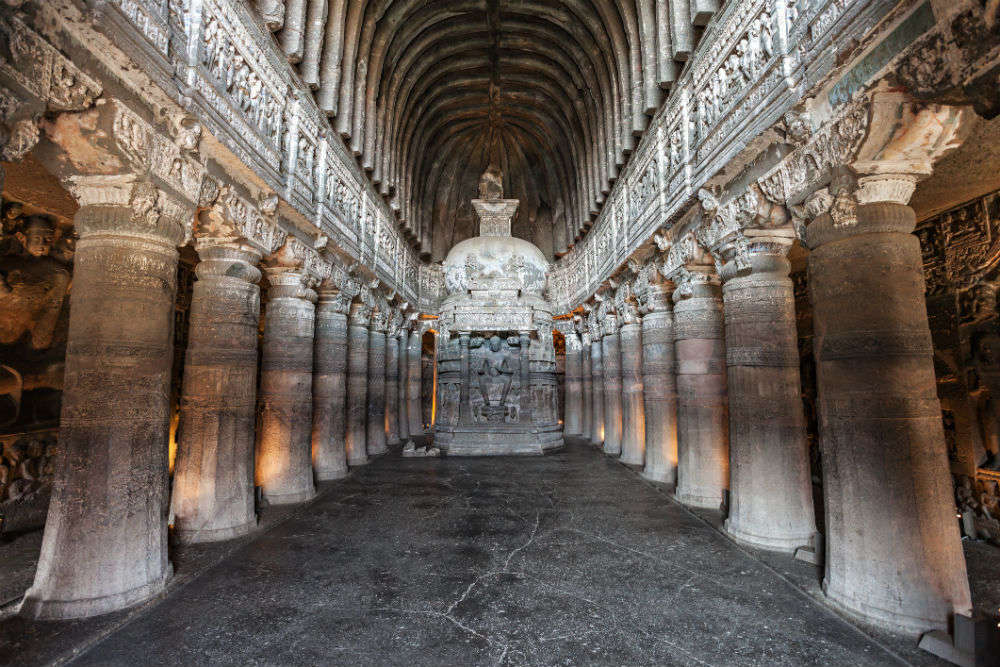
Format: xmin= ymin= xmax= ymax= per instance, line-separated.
xmin=642 ymin=282 xmax=677 ymax=484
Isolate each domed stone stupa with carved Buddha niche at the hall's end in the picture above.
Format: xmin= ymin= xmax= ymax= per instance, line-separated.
xmin=434 ymin=166 xmax=563 ymax=456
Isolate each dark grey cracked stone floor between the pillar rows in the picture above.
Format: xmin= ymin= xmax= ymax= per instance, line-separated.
xmin=0 ymin=443 xmax=1000 ymax=667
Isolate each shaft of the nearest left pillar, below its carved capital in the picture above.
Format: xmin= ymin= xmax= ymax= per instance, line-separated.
xmin=21 ymin=200 xmax=182 ymax=619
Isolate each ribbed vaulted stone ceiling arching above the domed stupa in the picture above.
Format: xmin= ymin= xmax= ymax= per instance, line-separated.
xmin=278 ymin=0 xmax=716 ymax=260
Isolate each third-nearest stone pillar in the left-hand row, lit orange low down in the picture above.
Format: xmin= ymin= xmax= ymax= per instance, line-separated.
xmin=255 ymin=266 xmax=316 ymax=505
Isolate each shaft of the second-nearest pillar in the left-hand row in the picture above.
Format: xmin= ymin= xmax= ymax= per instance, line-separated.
xmin=171 ymin=243 xmax=261 ymax=542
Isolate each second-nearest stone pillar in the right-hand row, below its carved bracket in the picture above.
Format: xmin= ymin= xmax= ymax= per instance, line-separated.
xmin=721 ymin=234 xmax=816 ymax=552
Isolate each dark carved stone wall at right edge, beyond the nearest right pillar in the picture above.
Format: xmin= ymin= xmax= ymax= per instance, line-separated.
xmin=916 ymin=191 xmax=1000 ymax=544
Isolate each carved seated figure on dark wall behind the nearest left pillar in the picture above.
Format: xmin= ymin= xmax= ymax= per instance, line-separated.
xmin=0 ymin=216 xmax=70 ymax=350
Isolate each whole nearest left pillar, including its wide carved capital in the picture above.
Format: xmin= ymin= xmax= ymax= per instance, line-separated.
xmin=20 ymin=100 xmax=203 ymax=619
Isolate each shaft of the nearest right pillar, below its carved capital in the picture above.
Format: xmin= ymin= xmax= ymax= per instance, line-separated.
xmin=807 ymin=185 xmax=971 ymax=633
